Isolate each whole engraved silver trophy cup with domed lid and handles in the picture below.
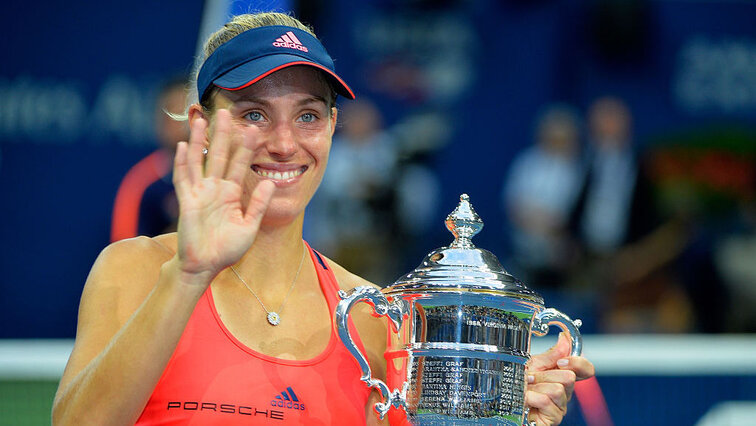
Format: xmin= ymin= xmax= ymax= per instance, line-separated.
xmin=335 ymin=194 xmax=582 ymax=426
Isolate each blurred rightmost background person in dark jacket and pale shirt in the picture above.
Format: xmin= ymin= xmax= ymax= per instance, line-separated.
xmin=571 ymin=96 xmax=693 ymax=332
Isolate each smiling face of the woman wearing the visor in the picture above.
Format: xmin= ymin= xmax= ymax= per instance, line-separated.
xmin=198 ymin=66 xmax=336 ymax=223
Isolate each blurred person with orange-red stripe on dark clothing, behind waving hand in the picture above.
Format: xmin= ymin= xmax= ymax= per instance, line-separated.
xmin=110 ymin=78 xmax=189 ymax=242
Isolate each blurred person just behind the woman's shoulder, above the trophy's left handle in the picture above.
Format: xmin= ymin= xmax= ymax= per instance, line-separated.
xmin=307 ymin=99 xmax=397 ymax=285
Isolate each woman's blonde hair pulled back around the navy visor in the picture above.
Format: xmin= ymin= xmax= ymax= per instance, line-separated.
xmin=171 ymin=12 xmax=336 ymax=120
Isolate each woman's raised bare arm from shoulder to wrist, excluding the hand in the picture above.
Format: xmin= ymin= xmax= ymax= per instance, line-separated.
xmin=53 ymin=239 xmax=207 ymax=425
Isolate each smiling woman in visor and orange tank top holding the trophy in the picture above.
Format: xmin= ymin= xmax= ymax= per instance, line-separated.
xmin=53 ymin=13 xmax=592 ymax=425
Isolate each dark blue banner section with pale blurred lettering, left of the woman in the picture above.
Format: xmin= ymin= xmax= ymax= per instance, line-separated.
xmin=0 ymin=0 xmax=202 ymax=337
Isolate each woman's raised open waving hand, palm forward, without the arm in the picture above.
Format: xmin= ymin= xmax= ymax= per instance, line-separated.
xmin=173 ymin=109 xmax=275 ymax=284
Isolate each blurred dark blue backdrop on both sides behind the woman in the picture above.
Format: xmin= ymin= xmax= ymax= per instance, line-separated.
xmin=0 ymin=0 xmax=756 ymax=337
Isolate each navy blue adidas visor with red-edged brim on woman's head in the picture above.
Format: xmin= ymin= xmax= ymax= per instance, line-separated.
xmin=197 ymin=25 xmax=354 ymax=100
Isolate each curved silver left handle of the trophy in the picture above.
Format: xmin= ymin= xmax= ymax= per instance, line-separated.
xmin=334 ymin=286 xmax=407 ymax=419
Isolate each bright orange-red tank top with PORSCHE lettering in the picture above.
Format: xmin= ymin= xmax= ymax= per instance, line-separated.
xmin=136 ymin=245 xmax=370 ymax=425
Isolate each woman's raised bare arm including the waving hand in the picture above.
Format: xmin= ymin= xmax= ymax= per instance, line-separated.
xmin=53 ymin=110 xmax=275 ymax=425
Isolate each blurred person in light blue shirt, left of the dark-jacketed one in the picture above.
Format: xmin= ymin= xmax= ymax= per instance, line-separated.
xmin=502 ymin=105 xmax=583 ymax=288
